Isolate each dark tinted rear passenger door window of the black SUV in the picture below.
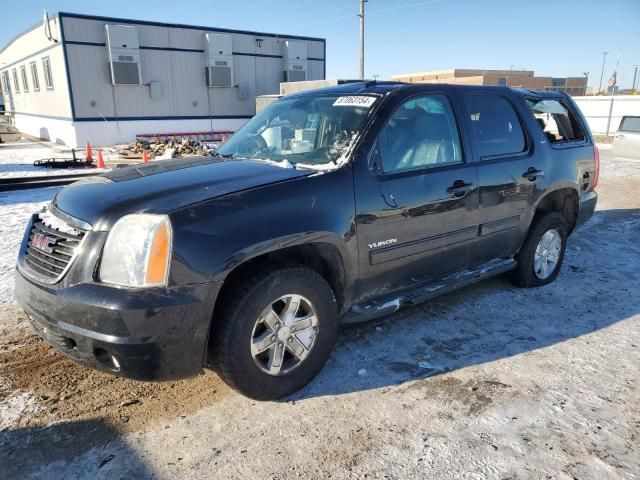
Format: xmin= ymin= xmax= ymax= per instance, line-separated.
xmin=466 ymin=94 xmax=527 ymax=159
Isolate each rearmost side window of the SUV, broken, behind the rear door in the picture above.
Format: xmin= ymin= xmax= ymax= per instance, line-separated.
xmin=527 ymin=99 xmax=585 ymax=145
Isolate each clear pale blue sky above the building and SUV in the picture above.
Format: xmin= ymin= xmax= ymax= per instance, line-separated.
xmin=5 ymin=0 xmax=640 ymax=88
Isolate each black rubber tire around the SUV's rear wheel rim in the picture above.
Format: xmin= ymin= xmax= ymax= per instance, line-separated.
xmin=511 ymin=212 xmax=567 ymax=288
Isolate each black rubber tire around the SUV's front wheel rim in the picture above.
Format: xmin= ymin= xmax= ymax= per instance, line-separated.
xmin=211 ymin=264 xmax=338 ymax=400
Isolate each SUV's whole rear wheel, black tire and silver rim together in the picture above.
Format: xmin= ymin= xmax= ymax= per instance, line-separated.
xmin=511 ymin=212 xmax=567 ymax=287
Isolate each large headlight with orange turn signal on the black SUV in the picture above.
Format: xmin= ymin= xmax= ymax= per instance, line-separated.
xmin=100 ymin=214 xmax=172 ymax=287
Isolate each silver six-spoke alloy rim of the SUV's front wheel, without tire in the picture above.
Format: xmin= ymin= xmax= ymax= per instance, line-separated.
xmin=251 ymin=294 xmax=319 ymax=375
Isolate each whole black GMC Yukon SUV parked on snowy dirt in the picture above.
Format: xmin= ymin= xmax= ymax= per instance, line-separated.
xmin=15 ymin=82 xmax=599 ymax=399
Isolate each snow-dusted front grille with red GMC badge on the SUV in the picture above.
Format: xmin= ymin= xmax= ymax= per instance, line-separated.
xmin=24 ymin=212 xmax=87 ymax=282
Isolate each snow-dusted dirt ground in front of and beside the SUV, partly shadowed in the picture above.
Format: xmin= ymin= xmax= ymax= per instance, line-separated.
xmin=0 ymin=148 xmax=640 ymax=480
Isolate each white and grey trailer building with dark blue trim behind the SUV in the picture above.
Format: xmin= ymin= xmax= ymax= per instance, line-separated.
xmin=0 ymin=12 xmax=326 ymax=146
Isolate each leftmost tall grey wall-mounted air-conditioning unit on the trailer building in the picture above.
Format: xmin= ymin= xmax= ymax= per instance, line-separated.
xmin=105 ymin=25 xmax=142 ymax=85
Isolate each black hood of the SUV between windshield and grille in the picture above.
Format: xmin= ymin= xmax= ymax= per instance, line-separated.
xmin=52 ymin=156 xmax=314 ymax=230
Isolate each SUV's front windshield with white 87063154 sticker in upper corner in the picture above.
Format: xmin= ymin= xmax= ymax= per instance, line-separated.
xmin=217 ymin=95 xmax=376 ymax=167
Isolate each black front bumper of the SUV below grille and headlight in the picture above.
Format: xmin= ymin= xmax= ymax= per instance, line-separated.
xmin=15 ymin=269 xmax=221 ymax=380
